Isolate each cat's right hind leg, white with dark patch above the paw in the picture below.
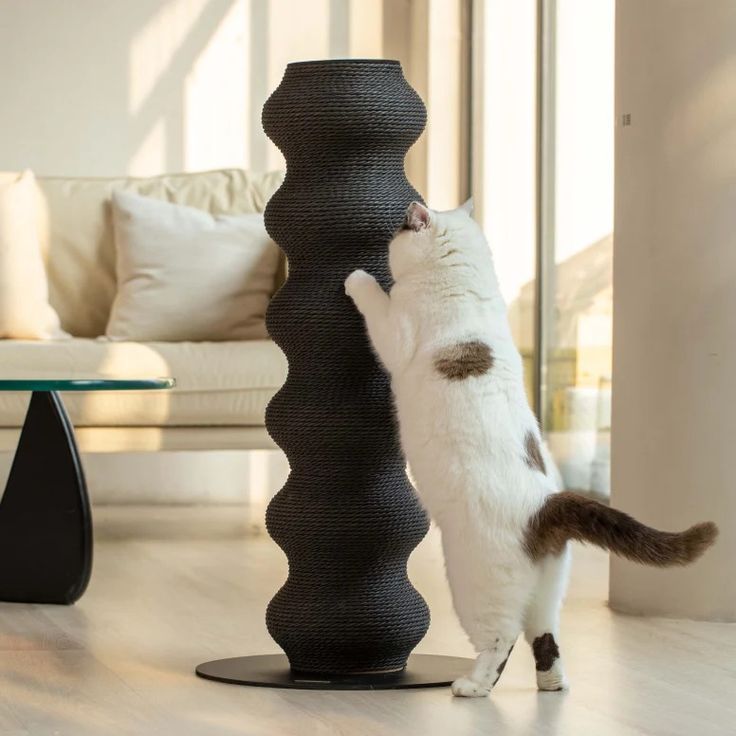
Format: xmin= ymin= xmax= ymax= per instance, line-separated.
xmin=524 ymin=545 xmax=570 ymax=690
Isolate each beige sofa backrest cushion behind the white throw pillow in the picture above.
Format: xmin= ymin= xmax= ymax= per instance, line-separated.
xmin=38 ymin=169 xmax=282 ymax=337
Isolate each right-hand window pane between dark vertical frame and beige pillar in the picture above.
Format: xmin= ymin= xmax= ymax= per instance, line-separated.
xmin=538 ymin=0 xmax=614 ymax=495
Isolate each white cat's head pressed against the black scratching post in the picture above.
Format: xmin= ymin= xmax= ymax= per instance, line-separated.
xmin=389 ymin=201 xmax=497 ymax=288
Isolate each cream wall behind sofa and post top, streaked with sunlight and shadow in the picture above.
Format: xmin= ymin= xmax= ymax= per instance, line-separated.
xmin=0 ymin=0 xmax=467 ymax=206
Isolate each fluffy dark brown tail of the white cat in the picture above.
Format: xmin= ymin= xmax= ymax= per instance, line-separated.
xmin=525 ymin=491 xmax=718 ymax=567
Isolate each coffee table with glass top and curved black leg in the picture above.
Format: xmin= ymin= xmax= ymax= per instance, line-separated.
xmin=0 ymin=374 xmax=175 ymax=604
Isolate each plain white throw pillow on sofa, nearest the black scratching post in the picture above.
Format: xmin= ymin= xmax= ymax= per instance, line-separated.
xmin=105 ymin=191 xmax=279 ymax=342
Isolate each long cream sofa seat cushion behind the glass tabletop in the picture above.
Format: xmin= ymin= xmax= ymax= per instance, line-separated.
xmin=0 ymin=338 xmax=286 ymax=427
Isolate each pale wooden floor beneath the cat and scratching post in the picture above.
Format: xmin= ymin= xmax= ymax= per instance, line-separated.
xmin=0 ymin=511 xmax=736 ymax=736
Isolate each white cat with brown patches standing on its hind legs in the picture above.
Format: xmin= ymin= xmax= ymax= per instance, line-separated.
xmin=345 ymin=202 xmax=717 ymax=696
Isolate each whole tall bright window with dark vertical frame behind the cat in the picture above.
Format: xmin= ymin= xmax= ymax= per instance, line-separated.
xmin=473 ymin=0 xmax=614 ymax=495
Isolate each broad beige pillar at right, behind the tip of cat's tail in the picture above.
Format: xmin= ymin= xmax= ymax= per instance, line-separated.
xmin=611 ymin=0 xmax=736 ymax=620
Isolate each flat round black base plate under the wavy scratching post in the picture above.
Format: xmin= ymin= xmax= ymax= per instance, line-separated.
xmin=196 ymin=654 xmax=473 ymax=690
